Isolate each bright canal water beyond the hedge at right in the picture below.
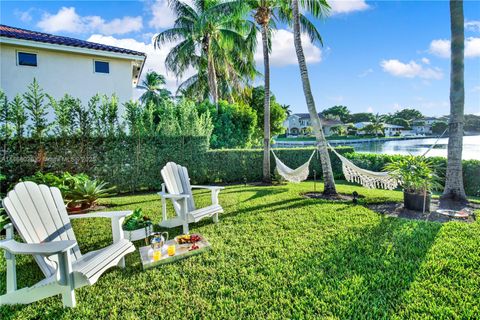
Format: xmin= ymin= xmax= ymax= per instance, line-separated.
xmin=347 ymin=135 xmax=480 ymax=160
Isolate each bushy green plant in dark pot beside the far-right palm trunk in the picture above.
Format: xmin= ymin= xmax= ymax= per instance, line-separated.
xmin=385 ymin=156 xmax=439 ymax=212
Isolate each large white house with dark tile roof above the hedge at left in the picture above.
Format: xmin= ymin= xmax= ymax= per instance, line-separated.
xmin=0 ymin=25 xmax=146 ymax=103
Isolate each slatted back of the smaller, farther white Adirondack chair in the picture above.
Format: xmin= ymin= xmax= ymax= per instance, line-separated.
xmin=161 ymin=162 xmax=195 ymax=214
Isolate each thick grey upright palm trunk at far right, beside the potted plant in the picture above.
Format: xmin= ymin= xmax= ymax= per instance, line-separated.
xmin=442 ymin=0 xmax=467 ymax=202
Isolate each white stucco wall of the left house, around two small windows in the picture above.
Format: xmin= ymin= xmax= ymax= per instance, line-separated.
xmin=0 ymin=43 xmax=139 ymax=103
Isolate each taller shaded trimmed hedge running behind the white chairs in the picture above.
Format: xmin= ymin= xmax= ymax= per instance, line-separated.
xmin=0 ymin=136 xmax=208 ymax=192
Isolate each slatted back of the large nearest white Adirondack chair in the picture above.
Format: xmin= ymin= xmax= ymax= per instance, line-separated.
xmin=3 ymin=181 xmax=82 ymax=277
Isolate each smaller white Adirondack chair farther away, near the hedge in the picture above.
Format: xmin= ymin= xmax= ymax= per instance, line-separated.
xmin=158 ymin=162 xmax=224 ymax=234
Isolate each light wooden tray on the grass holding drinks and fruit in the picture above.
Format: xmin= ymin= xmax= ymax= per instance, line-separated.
xmin=138 ymin=235 xmax=212 ymax=269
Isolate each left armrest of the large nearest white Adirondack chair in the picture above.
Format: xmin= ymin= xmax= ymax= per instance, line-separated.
xmin=0 ymin=240 xmax=77 ymax=256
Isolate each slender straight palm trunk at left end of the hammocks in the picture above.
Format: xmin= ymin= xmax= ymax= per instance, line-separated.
xmin=262 ymin=24 xmax=271 ymax=183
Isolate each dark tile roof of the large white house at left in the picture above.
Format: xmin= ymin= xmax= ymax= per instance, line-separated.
xmin=0 ymin=24 xmax=145 ymax=57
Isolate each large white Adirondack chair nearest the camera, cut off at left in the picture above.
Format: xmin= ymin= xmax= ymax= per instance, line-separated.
xmin=0 ymin=182 xmax=135 ymax=307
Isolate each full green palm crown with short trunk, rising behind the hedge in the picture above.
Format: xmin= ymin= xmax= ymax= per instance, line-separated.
xmin=154 ymin=0 xmax=254 ymax=105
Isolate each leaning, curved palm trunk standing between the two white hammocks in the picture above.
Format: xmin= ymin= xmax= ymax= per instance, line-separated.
xmin=292 ymin=0 xmax=337 ymax=195
